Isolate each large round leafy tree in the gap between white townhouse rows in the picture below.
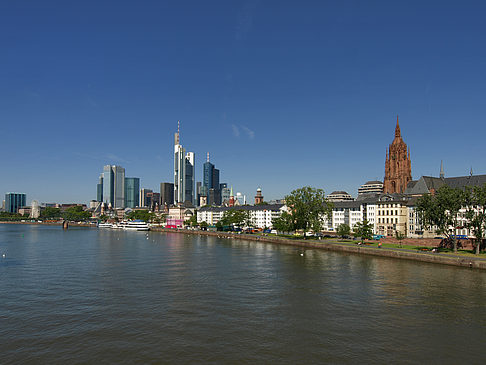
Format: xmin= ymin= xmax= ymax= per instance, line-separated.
xmin=285 ymin=186 xmax=332 ymax=238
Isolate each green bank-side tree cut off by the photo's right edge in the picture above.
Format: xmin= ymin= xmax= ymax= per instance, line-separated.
xmin=463 ymin=184 xmax=486 ymax=255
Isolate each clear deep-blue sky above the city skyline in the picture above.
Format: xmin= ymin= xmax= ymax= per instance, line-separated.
xmin=0 ymin=0 xmax=486 ymax=203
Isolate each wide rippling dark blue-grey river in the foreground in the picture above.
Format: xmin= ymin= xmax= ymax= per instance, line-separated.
xmin=0 ymin=224 xmax=486 ymax=364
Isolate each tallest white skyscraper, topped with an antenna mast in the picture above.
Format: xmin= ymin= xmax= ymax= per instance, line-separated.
xmin=174 ymin=122 xmax=195 ymax=204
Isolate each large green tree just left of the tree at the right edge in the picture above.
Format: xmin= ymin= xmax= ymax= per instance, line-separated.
xmin=416 ymin=185 xmax=464 ymax=252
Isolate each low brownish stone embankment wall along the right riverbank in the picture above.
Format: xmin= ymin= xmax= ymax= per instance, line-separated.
xmin=151 ymin=227 xmax=486 ymax=270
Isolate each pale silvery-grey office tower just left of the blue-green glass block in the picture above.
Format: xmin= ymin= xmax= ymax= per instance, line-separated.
xmin=103 ymin=165 xmax=125 ymax=208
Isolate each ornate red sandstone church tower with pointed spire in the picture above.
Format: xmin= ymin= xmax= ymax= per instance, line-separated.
xmin=383 ymin=115 xmax=412 ymax=193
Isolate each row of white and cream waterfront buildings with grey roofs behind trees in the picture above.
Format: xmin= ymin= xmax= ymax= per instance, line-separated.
xmin=197 ymin=175 xmax=486 ymax=238
